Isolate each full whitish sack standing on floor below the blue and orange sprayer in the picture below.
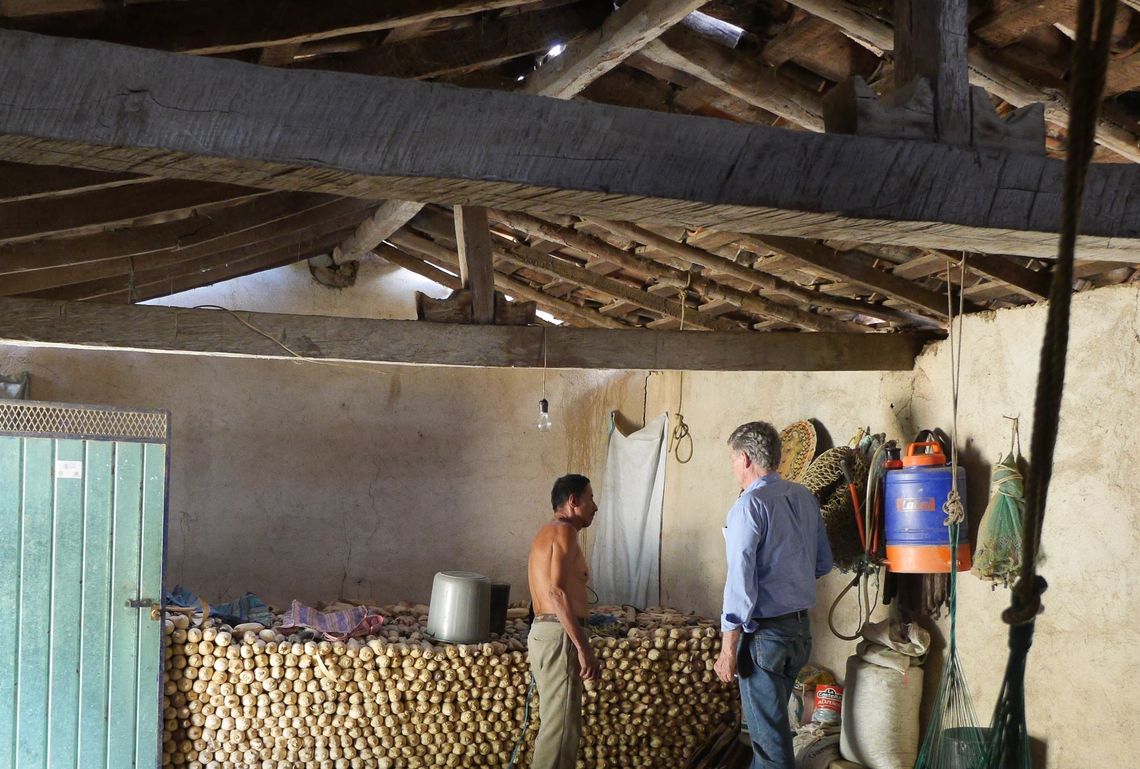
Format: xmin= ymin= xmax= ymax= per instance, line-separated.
xmin=839 ymin=620 xmax=930 ymax=769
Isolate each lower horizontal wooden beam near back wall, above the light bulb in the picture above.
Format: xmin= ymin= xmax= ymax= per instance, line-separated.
xmin=0 ymin=298 xmax=928 ymax=371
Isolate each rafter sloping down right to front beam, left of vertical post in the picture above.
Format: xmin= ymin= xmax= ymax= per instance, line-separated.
xmin=642 ymin=26 xmax=823 ymax=131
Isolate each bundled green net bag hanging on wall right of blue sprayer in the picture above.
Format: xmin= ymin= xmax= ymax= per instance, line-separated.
xmin=970 ymin=452 xmax=1025 ymax=587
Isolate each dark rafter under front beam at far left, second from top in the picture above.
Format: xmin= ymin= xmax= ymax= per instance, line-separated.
xmin=0 ymin=179 xmax=266 ymax=243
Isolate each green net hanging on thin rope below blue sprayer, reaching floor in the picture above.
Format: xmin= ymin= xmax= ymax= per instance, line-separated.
xmin=914 ymin=521 xmax=985 ymax=769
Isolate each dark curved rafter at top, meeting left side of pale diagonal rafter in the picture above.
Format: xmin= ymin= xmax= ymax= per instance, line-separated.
xmin=294 ymin=3 xmax=605 ymax=79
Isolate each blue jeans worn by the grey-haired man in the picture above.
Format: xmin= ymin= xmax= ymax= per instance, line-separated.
xmin=736 ymin=612 xmax=812 ymax=769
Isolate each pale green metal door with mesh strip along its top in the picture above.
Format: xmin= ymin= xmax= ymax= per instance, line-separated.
xmin=0 ymin=400 xmax=169 ymax=769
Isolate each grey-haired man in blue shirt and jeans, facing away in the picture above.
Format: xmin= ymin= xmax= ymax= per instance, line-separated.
xmin=716 ymin=422 xmax=831 ymax=769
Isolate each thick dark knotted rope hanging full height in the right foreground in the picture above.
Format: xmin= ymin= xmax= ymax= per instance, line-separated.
xmin=982 ymin=0 xmax=1116 ymax=769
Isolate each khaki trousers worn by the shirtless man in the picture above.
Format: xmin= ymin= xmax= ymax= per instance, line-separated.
xmin=527 ymin=622 xmax=581 ymax=769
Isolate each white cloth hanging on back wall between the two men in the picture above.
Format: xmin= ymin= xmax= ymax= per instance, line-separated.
xmin=591 ymin=414 xmax=669 ymax=608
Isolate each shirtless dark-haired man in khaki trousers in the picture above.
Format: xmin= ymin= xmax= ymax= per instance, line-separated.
xmin=527 ymin=475 xmax=599 ymax=769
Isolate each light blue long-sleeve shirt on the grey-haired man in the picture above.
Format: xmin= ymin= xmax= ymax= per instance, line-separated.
xmin=720 ymin=473 xmax=832 ymax=632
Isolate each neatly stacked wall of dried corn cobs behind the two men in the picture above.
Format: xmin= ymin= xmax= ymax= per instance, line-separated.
xmin=163 ymin=604 xmax=739 ymax=769
